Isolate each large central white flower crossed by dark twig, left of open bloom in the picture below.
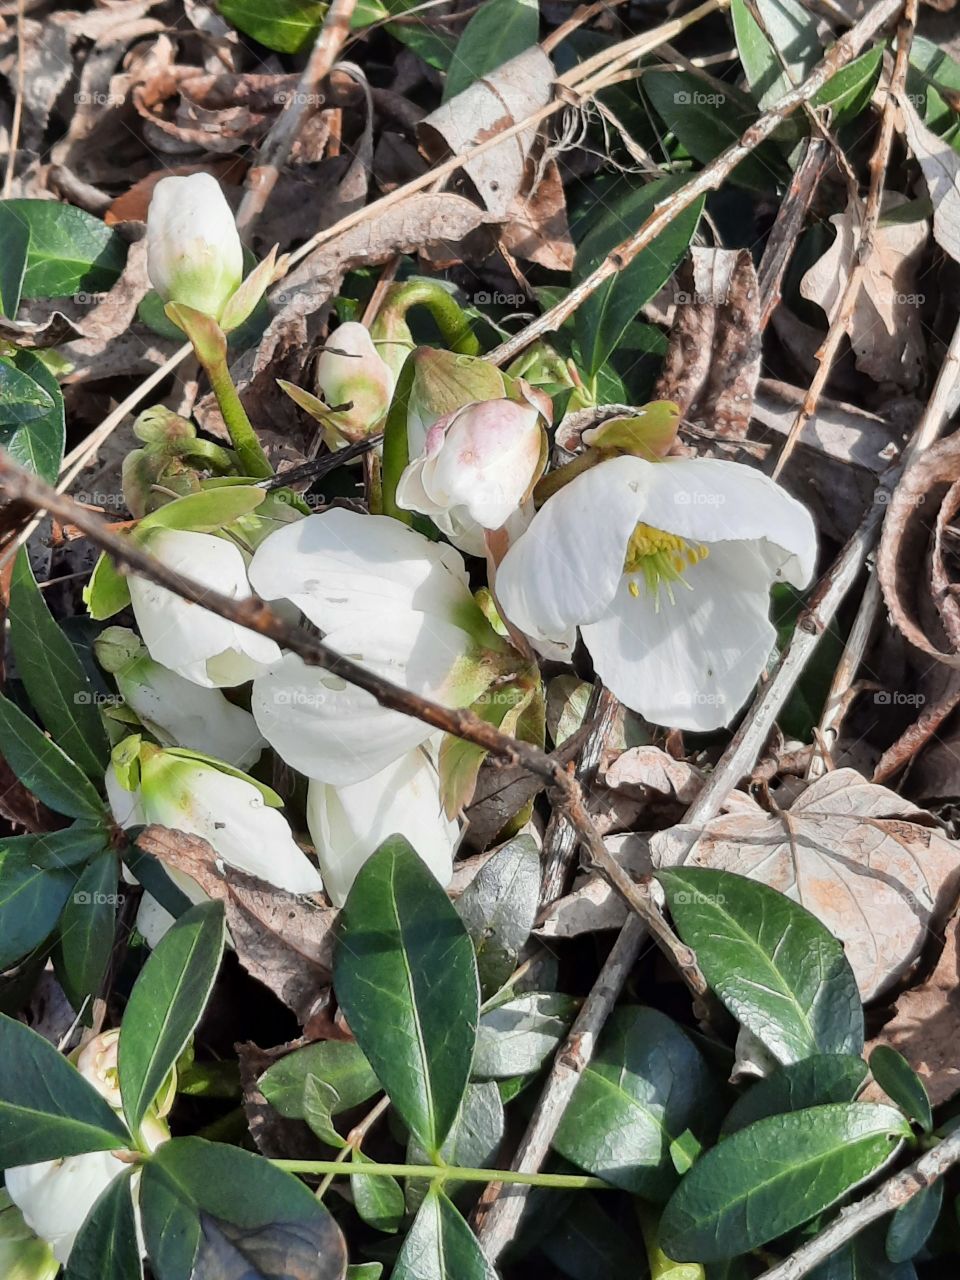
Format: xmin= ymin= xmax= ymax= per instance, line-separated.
xmin=250 ymin=508 xmax=504 ymax=786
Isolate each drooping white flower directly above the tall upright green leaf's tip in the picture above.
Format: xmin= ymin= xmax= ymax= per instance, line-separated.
xmin=307 ymin=742 xmax=460 ymax=906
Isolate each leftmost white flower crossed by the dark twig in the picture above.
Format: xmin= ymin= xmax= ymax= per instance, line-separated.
xmin=131 ymin=529 xmax=280 ymax=689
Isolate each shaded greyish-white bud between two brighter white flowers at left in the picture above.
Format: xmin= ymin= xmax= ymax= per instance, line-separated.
xmin=95 ymin=627 xmax=265 ymax=768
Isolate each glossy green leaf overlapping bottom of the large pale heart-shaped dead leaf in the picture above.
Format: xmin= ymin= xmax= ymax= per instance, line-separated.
xmin=657 ymin=867 xmax=863 ymax=1062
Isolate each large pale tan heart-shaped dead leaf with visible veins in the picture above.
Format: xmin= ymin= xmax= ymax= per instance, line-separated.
xmin=650 ymin=769 xmax=960 ymax=1000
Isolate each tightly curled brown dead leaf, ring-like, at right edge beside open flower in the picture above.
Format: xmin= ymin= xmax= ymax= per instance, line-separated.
xmin=877 ymin=435 xmax=960 ymax=667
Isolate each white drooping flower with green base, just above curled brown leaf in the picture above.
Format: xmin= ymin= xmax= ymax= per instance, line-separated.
xmin=141 ymin=753 xmax=321 ymax=893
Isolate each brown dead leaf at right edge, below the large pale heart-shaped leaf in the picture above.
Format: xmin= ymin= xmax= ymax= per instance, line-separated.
xmin=863 ymin=920 xmax=960 ymax=1107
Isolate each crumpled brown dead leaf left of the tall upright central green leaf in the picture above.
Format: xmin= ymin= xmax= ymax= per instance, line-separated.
xmin=137 ymin=826 xmax=337 ymax=1025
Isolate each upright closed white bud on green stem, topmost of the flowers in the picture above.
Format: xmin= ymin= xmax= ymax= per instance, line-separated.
xmin=147 ymin=173 xmax=243 ymax=320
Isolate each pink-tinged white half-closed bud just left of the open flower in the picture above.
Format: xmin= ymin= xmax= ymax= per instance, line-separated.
xmin=397 ymin=399 xmax=544 ymax=556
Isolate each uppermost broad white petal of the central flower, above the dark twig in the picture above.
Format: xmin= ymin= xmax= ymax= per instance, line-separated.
xmin=250 ymin=508 xmax=470 ymax=631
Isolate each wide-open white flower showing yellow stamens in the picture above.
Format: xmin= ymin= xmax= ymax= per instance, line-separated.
xmin=497 ymin=457 xmax=817 ymax=731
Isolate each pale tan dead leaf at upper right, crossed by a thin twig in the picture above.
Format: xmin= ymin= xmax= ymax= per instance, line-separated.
xmin=800 ymin=192 xmax=926 ymax=388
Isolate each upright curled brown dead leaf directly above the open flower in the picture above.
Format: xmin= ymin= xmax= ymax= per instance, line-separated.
xmin=654 ymin=248 xmax=760 ymax=440
